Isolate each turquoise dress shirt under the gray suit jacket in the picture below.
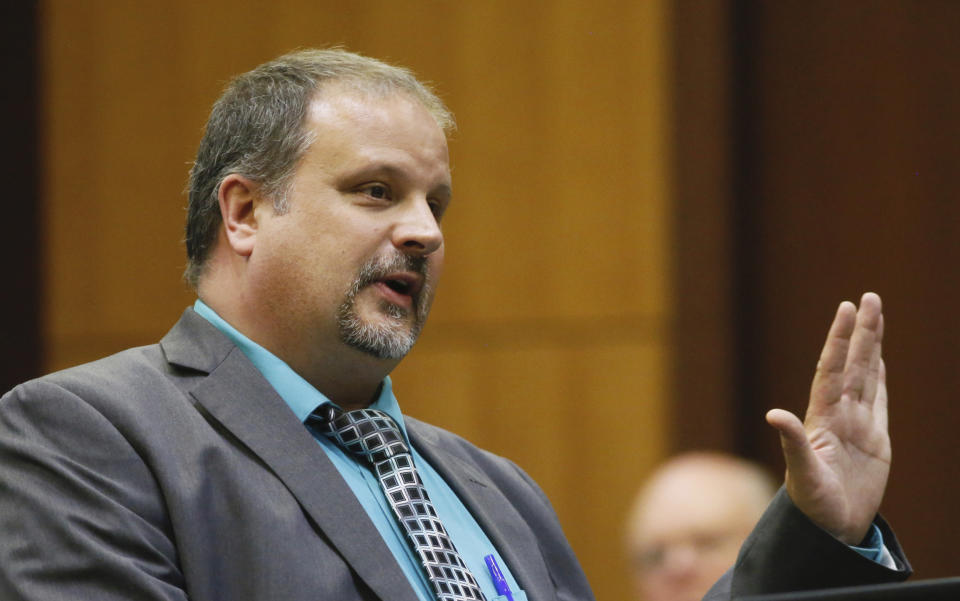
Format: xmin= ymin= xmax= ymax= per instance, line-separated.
xmin=193 ymin=300 xmax=526 ymax=601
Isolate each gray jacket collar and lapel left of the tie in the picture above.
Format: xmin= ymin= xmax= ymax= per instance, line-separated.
xmin=161 ymin=309 xmax=417 ymax=601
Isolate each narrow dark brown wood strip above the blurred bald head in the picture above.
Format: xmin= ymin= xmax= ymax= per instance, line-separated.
xmin=670 ymin=0 xmax=740 ymax=452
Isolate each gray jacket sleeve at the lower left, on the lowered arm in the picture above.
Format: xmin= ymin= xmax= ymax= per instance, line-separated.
xmin=0 ymin=381 xmax=187 ymax=601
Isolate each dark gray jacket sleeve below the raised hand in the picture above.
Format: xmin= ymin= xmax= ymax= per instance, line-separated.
xmin=704 ymin=489 xmax=911 ymax=601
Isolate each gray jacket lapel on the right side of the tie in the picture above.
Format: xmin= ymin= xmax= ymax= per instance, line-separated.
xmin=406 ymin=419 xmax=556 ymax=599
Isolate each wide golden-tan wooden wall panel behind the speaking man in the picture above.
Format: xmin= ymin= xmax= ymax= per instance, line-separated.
xmin=42 ymin=0 xmax=673 ymax=599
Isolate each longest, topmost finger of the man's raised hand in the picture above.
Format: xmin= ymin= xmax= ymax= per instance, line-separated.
xmin=841 ymin=292 xmax=883 ymax=403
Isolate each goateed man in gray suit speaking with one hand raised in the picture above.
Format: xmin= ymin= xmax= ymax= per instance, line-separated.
xmin=0 ymin=51 xmax=909 ymax=601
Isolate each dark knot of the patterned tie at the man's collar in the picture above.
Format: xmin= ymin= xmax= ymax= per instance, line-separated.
xmin=307 ymin=405 xmax=410 ymax=464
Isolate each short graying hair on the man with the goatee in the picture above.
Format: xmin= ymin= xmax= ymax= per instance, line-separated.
xmin=184 ymin=49 xmax=455 ymax=287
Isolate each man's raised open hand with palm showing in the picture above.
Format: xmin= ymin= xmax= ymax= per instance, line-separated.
xmin=767 ymin=292 xmax=890 ymax=545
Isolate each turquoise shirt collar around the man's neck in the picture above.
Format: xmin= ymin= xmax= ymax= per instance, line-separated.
xmin=193 ymin=299 xmax=407 ymax=438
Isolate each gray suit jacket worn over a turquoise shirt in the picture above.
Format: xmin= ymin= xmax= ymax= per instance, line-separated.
xmin=0 ymin=310 xmax=912 ymax=601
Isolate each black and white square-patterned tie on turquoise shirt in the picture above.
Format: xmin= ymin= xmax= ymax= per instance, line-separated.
xmin=307 ymin=405 xmax=484 ymax=601
